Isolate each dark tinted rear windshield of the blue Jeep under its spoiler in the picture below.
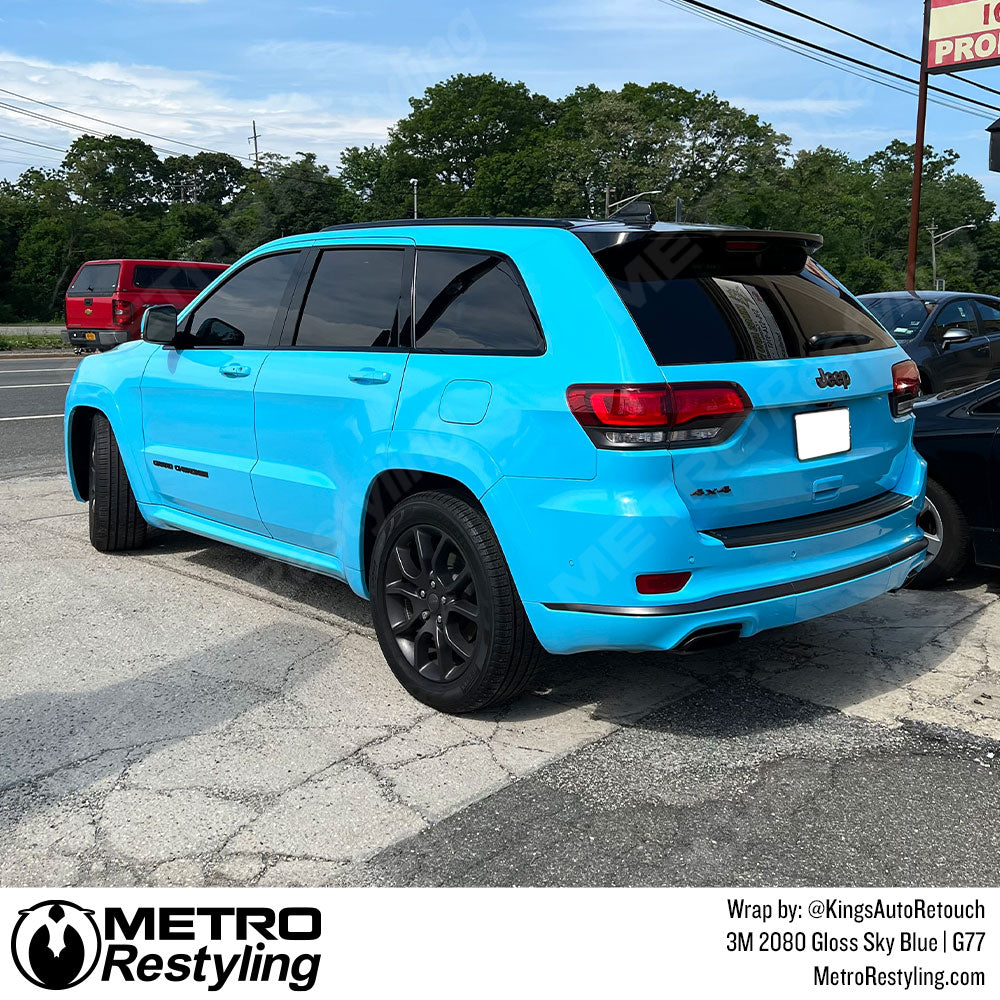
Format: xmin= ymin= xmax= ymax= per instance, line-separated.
xmin=595 ymin=241 xmax=895 ymax=365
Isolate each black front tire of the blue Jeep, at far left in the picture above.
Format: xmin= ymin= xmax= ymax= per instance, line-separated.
xmin=88 ymin=413 xmax=149 ymax=552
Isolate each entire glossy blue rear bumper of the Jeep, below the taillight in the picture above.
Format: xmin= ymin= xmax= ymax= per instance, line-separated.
xmin=483 ymin=449 xmax=926 ymax=653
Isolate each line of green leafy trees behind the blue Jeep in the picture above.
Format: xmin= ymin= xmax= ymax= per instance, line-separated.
xmin=0 ymin=74 xmax=1000 ymax=323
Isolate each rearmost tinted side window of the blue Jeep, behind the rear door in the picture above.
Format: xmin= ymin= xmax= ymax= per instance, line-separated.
xmin=415 ymin=250 xmax=543 ymax=354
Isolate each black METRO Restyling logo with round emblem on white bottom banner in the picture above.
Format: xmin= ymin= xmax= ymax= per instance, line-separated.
xmin=11 ymin=900 xmax=321 ymax=992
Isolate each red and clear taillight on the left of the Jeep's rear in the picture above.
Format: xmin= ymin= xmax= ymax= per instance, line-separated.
xmin=566 ymin=382 xmax=752 ymax=449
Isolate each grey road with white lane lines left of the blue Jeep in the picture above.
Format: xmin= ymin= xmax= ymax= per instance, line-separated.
xmin=0 ymin=354 xmax=81 ymax=480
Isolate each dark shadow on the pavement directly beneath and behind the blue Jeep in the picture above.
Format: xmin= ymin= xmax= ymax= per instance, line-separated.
xmin=113 ymin=533 xmax=996 ymax=736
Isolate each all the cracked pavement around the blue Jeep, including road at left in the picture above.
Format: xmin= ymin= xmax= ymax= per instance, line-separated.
xmin=0 ymin=356 xmax=1000 ymax=886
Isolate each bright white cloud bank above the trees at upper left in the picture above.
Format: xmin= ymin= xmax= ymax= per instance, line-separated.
xmin=0 ymin=51 xmax=398 ymax=176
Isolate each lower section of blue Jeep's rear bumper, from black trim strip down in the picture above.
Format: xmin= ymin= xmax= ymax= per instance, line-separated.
xmin=525 ymin=539 xmax=927 ymax=653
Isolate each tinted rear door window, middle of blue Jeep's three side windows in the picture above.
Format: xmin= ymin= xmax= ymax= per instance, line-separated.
xmin=295 ymin=247 xmax=404 ymax=348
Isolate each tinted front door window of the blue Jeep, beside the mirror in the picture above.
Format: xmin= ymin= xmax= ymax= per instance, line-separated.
xmin=188 ymin=253 xmax=299 ymax=347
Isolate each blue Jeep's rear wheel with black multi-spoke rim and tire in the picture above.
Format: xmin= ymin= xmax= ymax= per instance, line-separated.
xmin=369 ymin=492 xmax=542 ymax=714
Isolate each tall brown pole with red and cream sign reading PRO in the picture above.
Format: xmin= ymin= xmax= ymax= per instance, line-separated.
xmin=906 ymin=0 xmax=1000 ymax=292
